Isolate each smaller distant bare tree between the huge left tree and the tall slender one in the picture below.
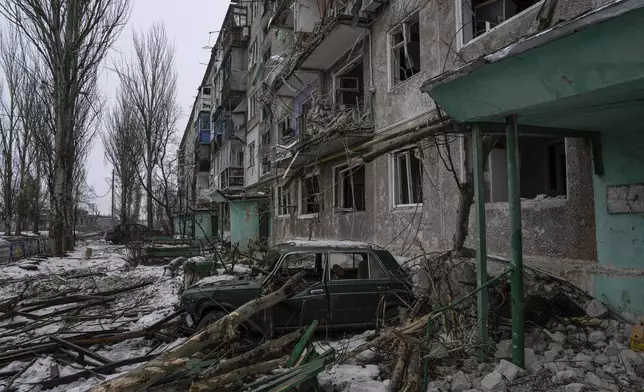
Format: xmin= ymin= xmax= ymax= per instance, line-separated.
xmin=101 ymin=96 xmax=143 ymax=227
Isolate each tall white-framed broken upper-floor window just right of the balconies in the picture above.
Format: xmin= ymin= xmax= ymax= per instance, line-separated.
xmin=389 ymin=14 xmax=420 ymax=86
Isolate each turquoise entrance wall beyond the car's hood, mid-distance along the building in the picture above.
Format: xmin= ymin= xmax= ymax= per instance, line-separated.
xmin=230 ymin=200 xmax=272 ymax=251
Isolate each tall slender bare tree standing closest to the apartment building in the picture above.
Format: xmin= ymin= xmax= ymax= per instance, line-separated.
xmin=117 ymin=24 xmax=179 ymax=227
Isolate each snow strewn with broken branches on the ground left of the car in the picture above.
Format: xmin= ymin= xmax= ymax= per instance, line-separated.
xmin=0 ymin=242 xmax=185 ymax=392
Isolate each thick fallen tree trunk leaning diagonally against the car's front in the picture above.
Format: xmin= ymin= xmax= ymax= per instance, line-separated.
xmin=90 ymin=271 xmax=304 ymax=392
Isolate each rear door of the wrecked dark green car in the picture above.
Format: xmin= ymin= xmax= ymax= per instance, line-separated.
xmin=326 ymin=250 xmax=398 ymax=326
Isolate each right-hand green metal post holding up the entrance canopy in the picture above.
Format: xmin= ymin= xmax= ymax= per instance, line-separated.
xmin=505 ymin=116 xmax=525 ymax=368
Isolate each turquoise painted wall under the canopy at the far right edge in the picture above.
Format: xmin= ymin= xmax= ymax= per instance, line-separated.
xmin=593 ymin=131 xmax=644 ymax=314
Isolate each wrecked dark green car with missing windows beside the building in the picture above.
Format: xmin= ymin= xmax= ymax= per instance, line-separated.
xmin=181 ymin=245 xmax=412 ymax=331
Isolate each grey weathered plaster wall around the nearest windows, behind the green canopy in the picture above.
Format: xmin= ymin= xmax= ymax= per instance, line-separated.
xmin=275 ymin=1 xmax=596 ymax=260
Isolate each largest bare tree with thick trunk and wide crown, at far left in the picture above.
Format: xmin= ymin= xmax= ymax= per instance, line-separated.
xmin=0 ymin=0 xmax=129 ymax=254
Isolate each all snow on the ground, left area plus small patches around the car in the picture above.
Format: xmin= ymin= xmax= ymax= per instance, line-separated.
xmin=0 ymin=241 xmax=389 ymax=392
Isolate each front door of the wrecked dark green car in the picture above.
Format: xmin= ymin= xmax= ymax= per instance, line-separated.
xmin=267 ymin=251 xmax=329 ymax=329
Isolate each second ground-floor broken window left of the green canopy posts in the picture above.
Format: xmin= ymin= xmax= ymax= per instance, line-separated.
xmin=333 ymin=165 xmax=366 ymax=211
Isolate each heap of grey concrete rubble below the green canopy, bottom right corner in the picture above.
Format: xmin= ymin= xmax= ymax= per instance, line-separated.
xmin=428 ymin=272 xmax=644 ymax=392
